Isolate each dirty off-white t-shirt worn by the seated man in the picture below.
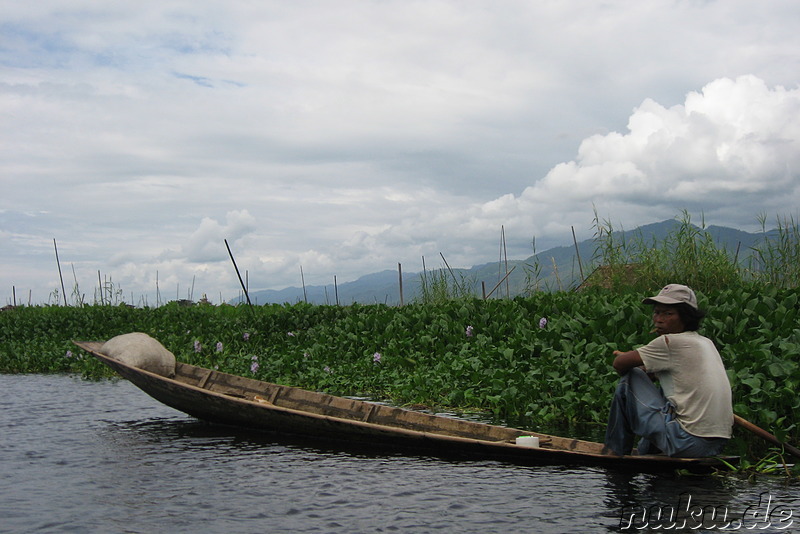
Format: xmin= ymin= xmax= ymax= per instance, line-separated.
xmin=636 ymin=331 xmax=733 ymax=438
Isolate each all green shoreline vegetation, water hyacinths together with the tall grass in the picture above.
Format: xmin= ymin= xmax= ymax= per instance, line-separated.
xmin=0 ymin=212 xmax=800 ymax=474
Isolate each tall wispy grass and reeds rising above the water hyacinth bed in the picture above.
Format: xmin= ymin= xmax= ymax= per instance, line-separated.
xmin=418 ymin=210 xmax=800 ymax=304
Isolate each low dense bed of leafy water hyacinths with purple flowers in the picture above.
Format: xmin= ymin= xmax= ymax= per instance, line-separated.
xmin=0 ymin=287 xmax=800 ymax=454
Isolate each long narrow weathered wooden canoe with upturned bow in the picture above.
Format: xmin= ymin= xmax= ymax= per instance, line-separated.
xmin=74 ymin=341 xmax=737 ymax=472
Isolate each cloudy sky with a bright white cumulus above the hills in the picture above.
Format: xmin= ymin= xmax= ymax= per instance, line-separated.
xmin=0 ymin=0 xmax=800 ymax=305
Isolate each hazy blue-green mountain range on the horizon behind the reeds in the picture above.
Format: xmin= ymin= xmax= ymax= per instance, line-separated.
xmin=230 ymin=219 xmax=771 ymax=305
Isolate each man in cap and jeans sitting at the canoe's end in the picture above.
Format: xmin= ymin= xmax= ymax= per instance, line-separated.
xmin=605 ymin=284 xmax=733 ymax=457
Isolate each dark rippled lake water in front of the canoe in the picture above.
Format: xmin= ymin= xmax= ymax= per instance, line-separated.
xmin=0 ymin=375 xmax=800 ymax=534
